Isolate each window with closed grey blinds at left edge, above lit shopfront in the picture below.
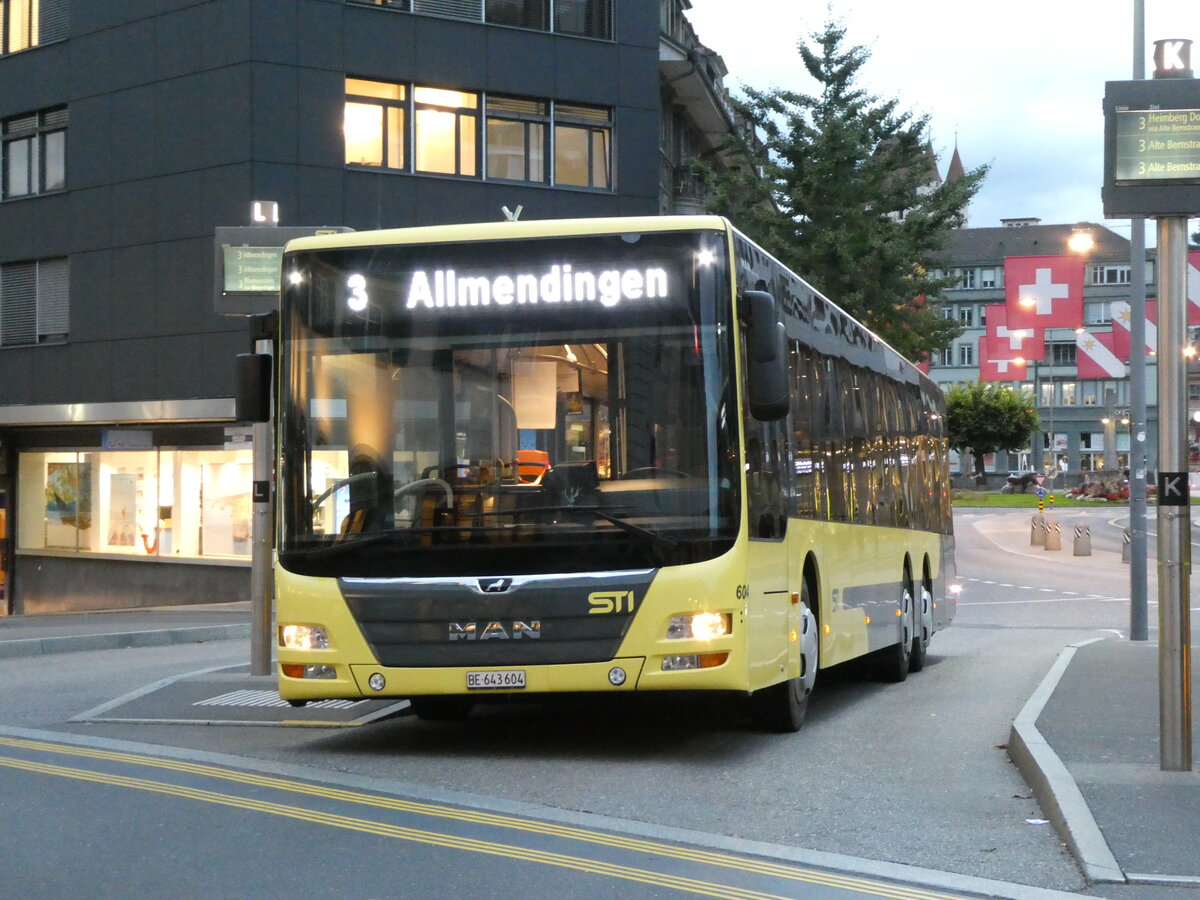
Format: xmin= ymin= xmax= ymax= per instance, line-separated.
xmin=0 ymin=257 xmax=71 ymax=347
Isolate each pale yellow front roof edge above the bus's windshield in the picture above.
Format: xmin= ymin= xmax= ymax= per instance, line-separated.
xmin=284 ymin=216 xmax=731 ymax=253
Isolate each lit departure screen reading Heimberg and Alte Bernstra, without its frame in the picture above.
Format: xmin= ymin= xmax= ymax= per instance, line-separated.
xmin=1114 ymin=109 xmax=1200 ymax=182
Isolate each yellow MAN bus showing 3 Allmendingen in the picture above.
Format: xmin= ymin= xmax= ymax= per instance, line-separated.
xmin=275 ymin=216 xmax=954 ymax=731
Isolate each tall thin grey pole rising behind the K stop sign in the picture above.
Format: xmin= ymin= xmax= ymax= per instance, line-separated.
xmin=1129 ymin=0 xmax=1150 ymax=641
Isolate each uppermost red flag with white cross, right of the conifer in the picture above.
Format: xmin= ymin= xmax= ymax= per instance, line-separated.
xmin=1004 ymin=257 xmax=1084 ymax=329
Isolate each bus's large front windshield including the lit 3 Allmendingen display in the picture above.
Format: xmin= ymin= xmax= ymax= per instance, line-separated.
xmin=278 ymin=232 xmax=740 ymax=577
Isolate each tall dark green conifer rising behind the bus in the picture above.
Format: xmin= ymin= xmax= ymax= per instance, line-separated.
xmin=708 ymin=22 xmax=986 ymax=361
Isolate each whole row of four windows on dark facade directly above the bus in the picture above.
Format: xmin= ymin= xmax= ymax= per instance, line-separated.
xmin=343 ymin=78 xmax=612 ymax=190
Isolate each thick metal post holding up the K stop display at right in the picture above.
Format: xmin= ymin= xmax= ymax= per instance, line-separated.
xmin=1152 ymin=216 xmax=1192 ymax=772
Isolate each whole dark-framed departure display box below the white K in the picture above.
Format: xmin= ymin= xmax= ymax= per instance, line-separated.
xmin=1102 ymin=72 xmax=1200 ymax=218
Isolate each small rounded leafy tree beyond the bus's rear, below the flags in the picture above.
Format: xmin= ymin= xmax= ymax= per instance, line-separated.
xmin=946 ymin=382 xmax=1040 ymax=480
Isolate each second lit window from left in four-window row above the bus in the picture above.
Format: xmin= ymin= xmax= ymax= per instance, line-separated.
xmin=413 ymin=86 xmax=479 ymax=178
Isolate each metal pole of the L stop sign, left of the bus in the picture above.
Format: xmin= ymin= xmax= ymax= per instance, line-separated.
xmin=250 ymin=340 xmax=275 ymax=676
